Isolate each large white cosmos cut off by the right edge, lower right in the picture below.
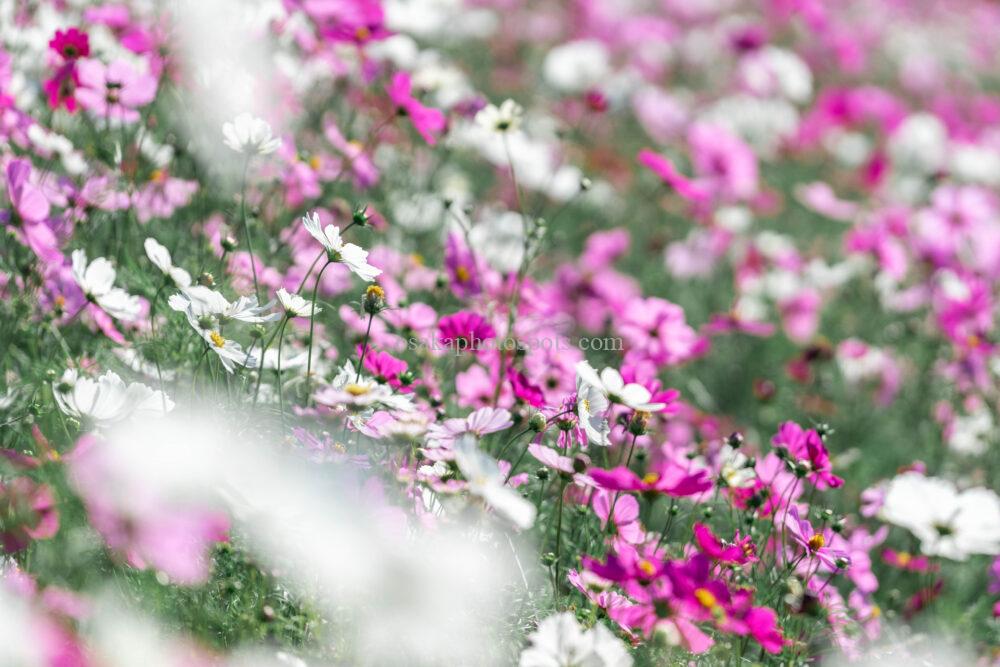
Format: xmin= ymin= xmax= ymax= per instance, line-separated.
xmin=881 ymin=471 xmax=1000 ymax=560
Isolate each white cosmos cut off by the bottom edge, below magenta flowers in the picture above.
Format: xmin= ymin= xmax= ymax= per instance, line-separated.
xmin=518 ymin=611 xmax=632 ymax=667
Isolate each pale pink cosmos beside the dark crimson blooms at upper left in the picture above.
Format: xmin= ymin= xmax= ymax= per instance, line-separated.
xmin=76 ymin=58 xmax=157 ymax=123
